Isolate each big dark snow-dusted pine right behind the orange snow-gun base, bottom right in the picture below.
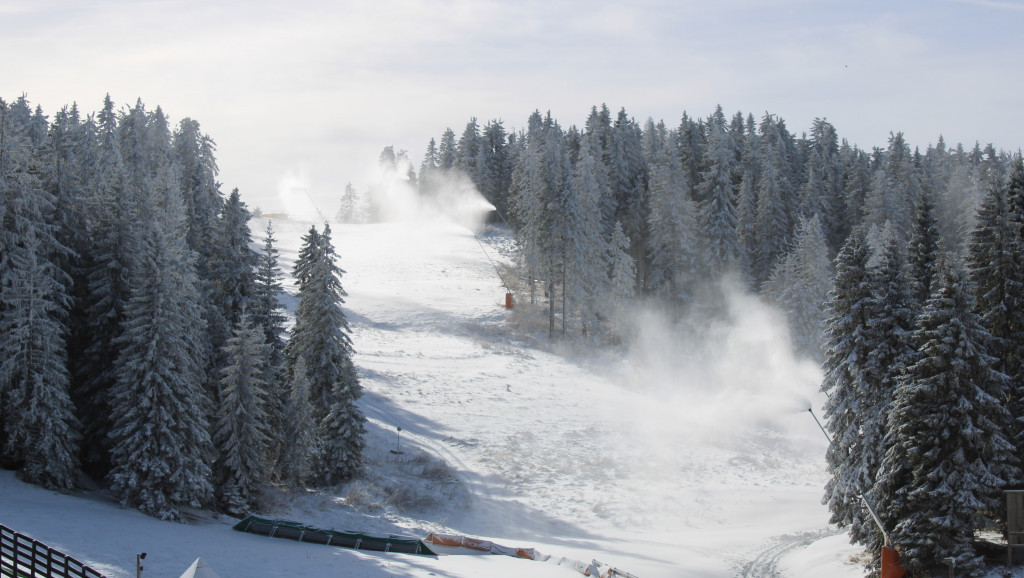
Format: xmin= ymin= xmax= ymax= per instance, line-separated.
xmin=879 ymin=267 xmax=1020 ymax=576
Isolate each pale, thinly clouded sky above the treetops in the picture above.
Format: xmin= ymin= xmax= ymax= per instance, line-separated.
xmin=0 ymin=0 xmax=1024 ymax=215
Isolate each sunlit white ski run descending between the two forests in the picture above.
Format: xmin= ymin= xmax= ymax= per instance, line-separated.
xmin=281 ymin=221 xmax=856 ymax=576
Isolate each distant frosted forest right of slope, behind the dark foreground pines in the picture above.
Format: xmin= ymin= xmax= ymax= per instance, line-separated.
xmin=378 ymin=106 xmax=1011 ymax=352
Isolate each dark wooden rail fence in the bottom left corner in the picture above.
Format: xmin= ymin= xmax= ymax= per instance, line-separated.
xmin=0 ymin=525 xmax=104 ymax=578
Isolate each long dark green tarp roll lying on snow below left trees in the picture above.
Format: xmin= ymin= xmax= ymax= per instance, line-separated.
xmin=234 ymin=515 xmax=437 ymax=555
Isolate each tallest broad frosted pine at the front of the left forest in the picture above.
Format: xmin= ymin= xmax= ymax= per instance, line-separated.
xmin=108 ymin=101 xmax=214 ymax=520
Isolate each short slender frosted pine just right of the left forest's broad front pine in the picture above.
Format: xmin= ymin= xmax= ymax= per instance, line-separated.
xmin=215 ymin=313 xmax=270 ymax=515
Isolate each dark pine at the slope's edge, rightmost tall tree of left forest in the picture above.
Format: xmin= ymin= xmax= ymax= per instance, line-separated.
xmin=285 ymin=224 xmax=366 ymax=485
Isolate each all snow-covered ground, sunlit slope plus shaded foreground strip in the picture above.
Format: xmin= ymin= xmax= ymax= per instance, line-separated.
xmin=0 ymin=210 xmax=876 ymax=578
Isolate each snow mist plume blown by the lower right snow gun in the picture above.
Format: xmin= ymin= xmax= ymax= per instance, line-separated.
xmin=626 ymin=274 xmax=821 ymax=447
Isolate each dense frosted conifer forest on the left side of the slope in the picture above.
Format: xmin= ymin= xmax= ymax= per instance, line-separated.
xmin=0 ymin=96 xmax=364 ymax=520
